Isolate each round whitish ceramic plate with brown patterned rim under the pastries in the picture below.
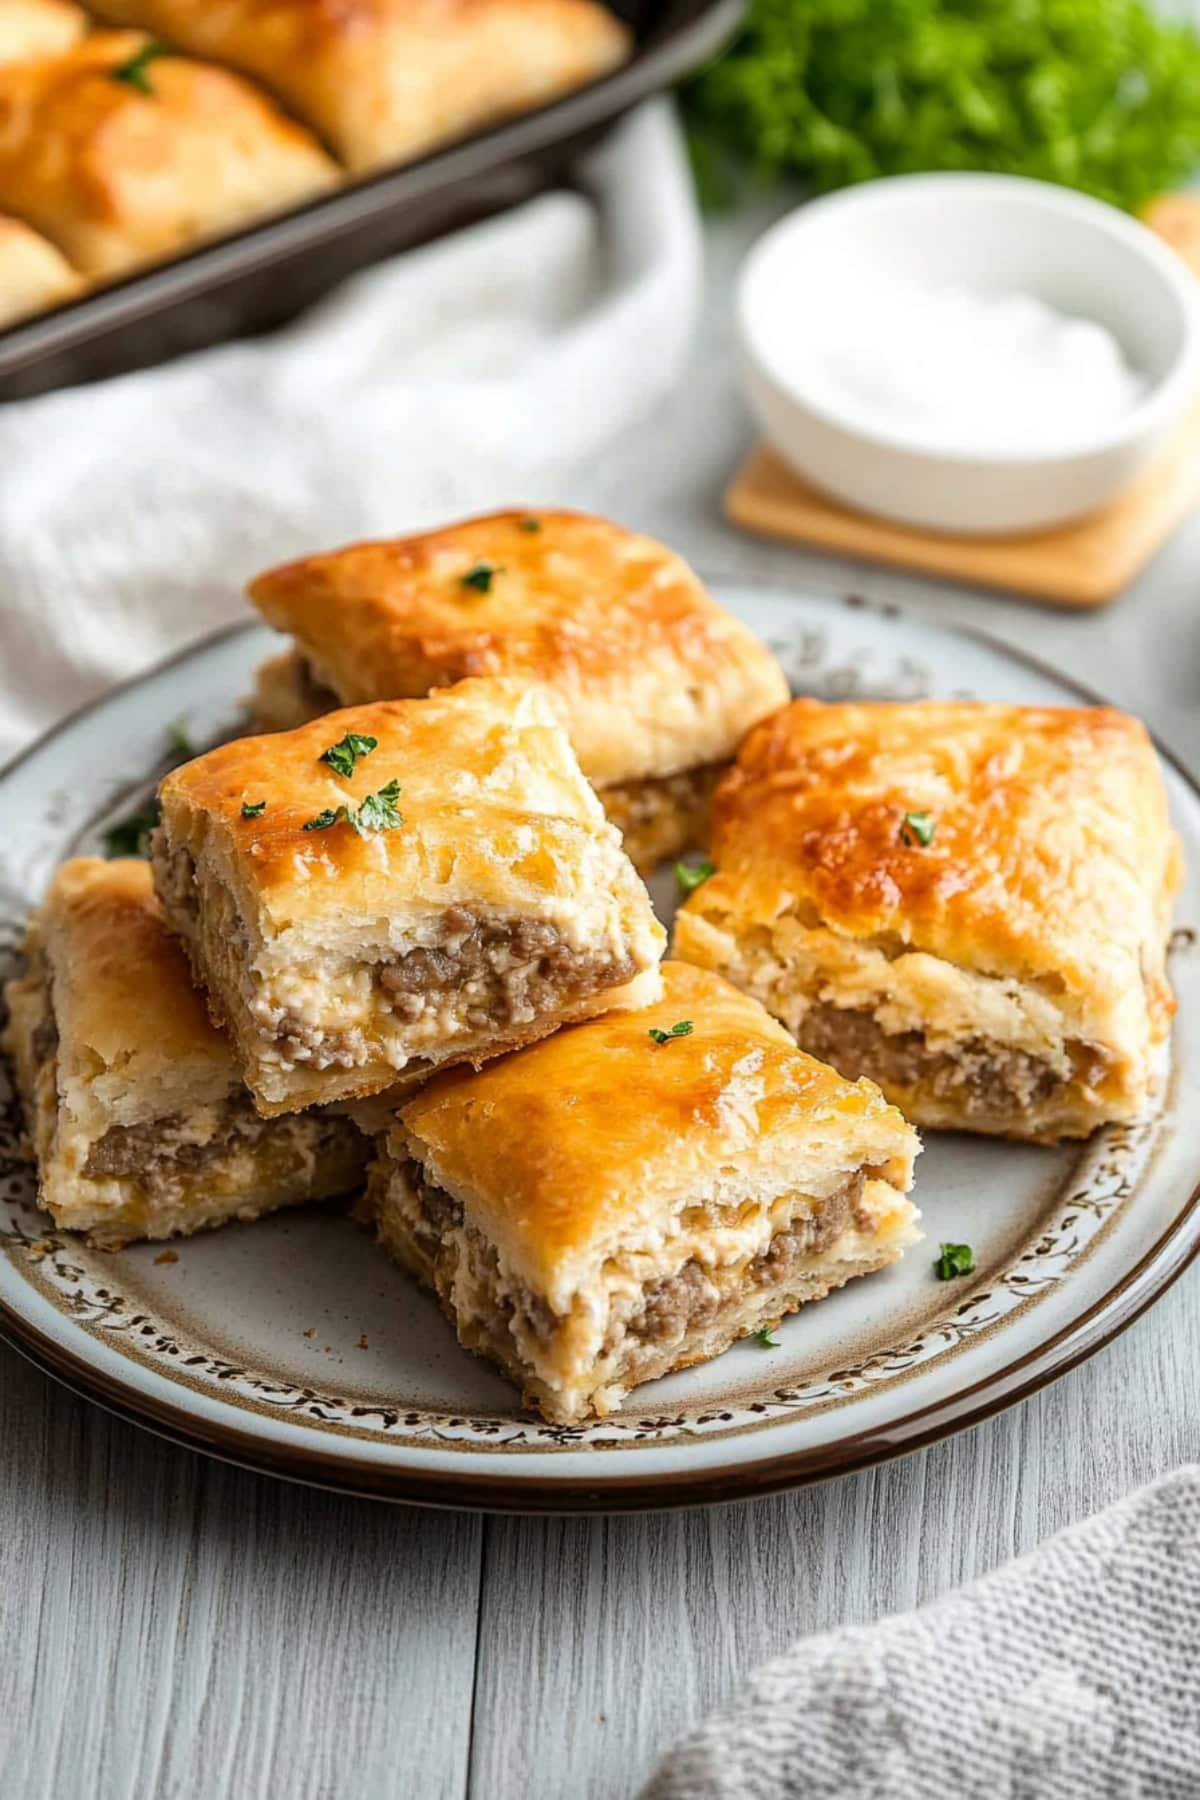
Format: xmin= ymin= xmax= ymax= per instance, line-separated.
xmin=0 ymin=585 xmax=1200 ymax=1512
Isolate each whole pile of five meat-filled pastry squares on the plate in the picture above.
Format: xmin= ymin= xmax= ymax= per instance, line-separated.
xmin=9 ymin=513 xmax=1178 ymax=1420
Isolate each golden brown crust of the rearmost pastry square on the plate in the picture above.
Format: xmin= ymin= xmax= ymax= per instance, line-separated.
xmin=250 ymin=511 xmax=788 ymax=787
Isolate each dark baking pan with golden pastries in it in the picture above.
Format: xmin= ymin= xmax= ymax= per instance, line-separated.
xmin=0 ymin=0 xmax=743 ymax=400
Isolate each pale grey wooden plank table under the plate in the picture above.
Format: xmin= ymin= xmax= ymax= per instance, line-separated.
xmin=0 ymin=204 xmax=1200 ymax=1800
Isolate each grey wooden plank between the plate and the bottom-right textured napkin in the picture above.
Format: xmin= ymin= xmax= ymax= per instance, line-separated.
xmin=470 ymin=1267 xmax=1200 ymax=1800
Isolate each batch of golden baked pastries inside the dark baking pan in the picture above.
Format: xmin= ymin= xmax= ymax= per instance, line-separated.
xmin=0 ymin=0 xmax=630 ymax=326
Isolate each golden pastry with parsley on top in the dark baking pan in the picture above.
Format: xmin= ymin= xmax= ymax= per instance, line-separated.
xmin=0 ymin=31 xmax=336 ymax=277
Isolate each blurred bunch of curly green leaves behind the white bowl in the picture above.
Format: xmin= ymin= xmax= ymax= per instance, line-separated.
xmin=687 ymin=0 xmax=1200 ymax=211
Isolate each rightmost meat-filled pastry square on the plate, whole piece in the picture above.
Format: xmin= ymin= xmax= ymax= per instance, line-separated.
xmin=675 ymin=700 xmax=1180 ymax=1141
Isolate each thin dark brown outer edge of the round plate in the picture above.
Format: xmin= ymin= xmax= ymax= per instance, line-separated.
xmin=0 ymin=597 xmax=1200 ymax=1514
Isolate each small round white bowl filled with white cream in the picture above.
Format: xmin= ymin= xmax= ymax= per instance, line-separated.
xmin=738 ymin=175 xmax=1200 ymax=535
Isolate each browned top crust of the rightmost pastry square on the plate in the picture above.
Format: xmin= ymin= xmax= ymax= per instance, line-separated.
xmin=689 ymin=700 xmax=1178 ymax=1021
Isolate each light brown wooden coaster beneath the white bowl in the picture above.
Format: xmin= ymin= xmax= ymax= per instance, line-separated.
xmin=725 ymin=194 xmax=1200 ymax=607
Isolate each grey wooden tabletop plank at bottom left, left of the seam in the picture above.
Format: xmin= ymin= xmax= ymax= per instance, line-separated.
xmin=0 ymin=1346 xmax=482 ymax=1800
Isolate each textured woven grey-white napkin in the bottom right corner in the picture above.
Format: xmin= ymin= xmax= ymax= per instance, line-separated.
xmin=642 ymin=1467 xmax=1200 ymax=1800
